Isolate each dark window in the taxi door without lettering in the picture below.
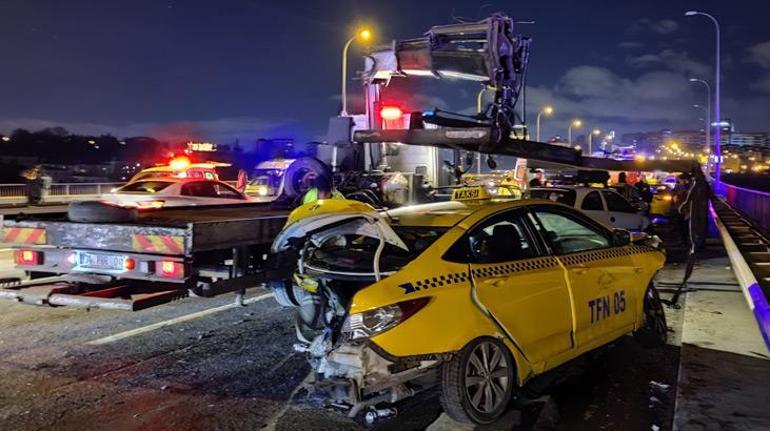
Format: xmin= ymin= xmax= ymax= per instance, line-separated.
xmin=468 ymin=213 xmax=537 ymax=263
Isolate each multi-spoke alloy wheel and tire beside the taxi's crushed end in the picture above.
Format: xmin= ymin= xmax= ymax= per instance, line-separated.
xmin=441 ymin=337 xmax=516 ymax=425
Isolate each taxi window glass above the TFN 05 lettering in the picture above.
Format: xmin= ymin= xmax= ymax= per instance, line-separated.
xmin=534 ymin=209 xmax=610 ymax=254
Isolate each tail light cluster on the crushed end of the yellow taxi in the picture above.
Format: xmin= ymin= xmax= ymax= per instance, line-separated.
xmin=342 ymin=298 xmax=430 ymax=341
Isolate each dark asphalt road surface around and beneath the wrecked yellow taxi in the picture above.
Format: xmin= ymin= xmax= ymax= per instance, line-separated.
xmin=0 ymin=274 xmax=678 ymax=431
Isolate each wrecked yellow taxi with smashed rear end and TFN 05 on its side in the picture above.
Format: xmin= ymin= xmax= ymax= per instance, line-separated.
xmin=270 ymin=188 xmax=667 ymax=424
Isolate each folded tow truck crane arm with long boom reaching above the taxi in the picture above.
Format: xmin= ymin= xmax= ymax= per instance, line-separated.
xmin=353 ymin=14 xmax=698 ymax=172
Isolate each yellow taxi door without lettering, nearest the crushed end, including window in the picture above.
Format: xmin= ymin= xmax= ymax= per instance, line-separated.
xmin=469 ymin=211 xmax=574 ymax=363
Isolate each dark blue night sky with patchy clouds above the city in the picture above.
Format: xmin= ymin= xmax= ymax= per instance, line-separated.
xmin=0 ymin=0 xmax=770 ymax=142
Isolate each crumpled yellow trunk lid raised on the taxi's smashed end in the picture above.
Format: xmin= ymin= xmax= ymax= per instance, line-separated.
xmin=272 ymin=199 xmax=409 ymax=252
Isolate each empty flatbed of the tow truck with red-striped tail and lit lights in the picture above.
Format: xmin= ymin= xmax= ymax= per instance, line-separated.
xmin=0 ymin=204 xmax=289 ymax=311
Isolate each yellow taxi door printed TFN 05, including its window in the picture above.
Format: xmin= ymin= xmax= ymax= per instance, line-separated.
xmin=532 ymin=206 xmax=642 ymax=348
